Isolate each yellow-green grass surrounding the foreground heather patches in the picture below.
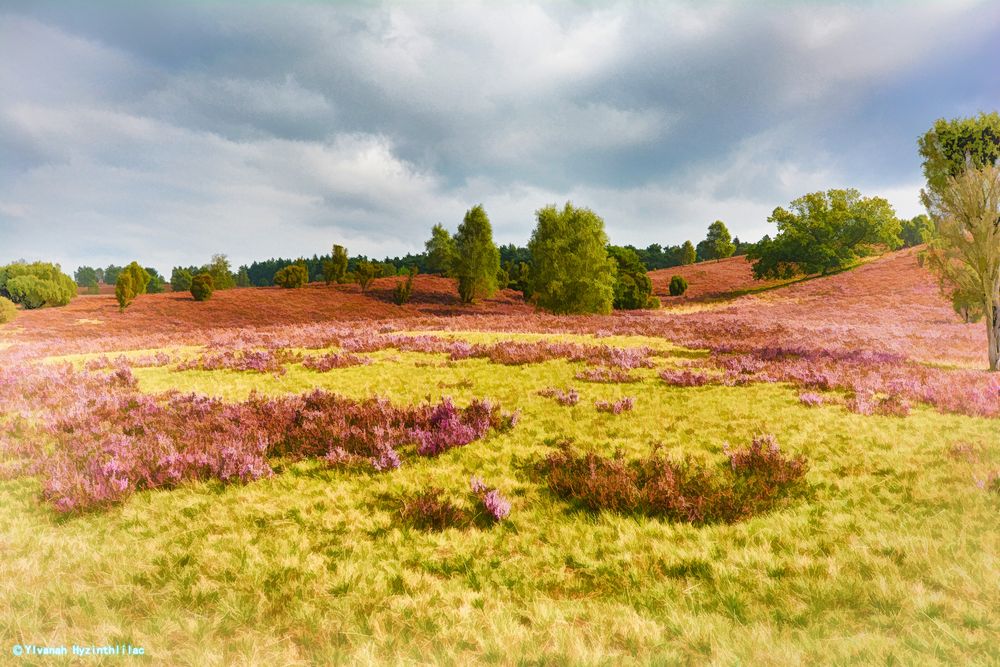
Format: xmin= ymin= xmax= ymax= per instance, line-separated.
xmin=0 ymin=335 xmax=1000 ymax=665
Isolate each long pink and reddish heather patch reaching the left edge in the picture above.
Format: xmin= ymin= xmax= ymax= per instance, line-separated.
xmin=9 ymin=364 xmax=516 ymax=511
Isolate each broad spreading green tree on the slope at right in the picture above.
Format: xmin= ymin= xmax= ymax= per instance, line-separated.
xmin=747 ymin=189 xmax=900 ymax=280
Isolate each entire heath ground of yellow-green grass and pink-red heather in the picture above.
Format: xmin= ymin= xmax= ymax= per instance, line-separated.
xmin=0 ymin=250 xmax=1000 ymax=665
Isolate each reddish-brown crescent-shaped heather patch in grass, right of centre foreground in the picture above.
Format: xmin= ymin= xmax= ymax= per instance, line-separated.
xmin=540 ymin=436 xmax=808 ymax=524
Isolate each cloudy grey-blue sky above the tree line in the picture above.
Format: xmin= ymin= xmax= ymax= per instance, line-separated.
xmin=0 ymin=0 xmax=1000 ymax=274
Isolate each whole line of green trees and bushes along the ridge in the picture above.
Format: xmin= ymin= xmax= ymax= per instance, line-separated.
xmin=0 ymin=112 xmax=1000 ymax=371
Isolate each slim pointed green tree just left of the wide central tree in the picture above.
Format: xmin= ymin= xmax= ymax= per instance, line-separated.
xmin=453 ymin=204 xmax=500 ymax=303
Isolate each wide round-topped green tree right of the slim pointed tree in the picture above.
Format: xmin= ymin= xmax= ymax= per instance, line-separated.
xmin=528 ymin=202 xmax=615 ymax=314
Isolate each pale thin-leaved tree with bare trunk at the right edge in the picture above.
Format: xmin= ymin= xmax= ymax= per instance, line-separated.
xmin=923 ymin=165 xmax=1000 ymax=371
